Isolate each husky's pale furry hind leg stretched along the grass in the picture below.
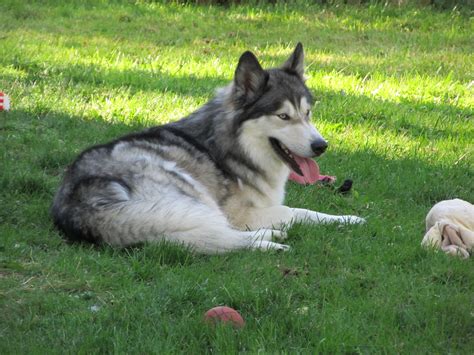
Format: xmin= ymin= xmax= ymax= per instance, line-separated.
xmin=89 ymin=195 xmax=289 ymax=254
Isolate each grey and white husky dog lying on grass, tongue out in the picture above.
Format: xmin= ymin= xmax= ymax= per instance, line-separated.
xmin=52 ymin=43 xmax=364 ymax=253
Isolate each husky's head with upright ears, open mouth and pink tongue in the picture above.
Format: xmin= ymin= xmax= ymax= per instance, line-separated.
xmin=232 ymin=43 xmax=327 ymax=182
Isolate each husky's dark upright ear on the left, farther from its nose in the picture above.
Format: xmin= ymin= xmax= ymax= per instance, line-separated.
xmin=234 ymin=51 xmax=268 ymax=101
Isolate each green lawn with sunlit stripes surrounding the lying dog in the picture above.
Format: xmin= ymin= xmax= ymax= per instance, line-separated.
xmin=0 ymin=0 xmax=474 ymax=354
